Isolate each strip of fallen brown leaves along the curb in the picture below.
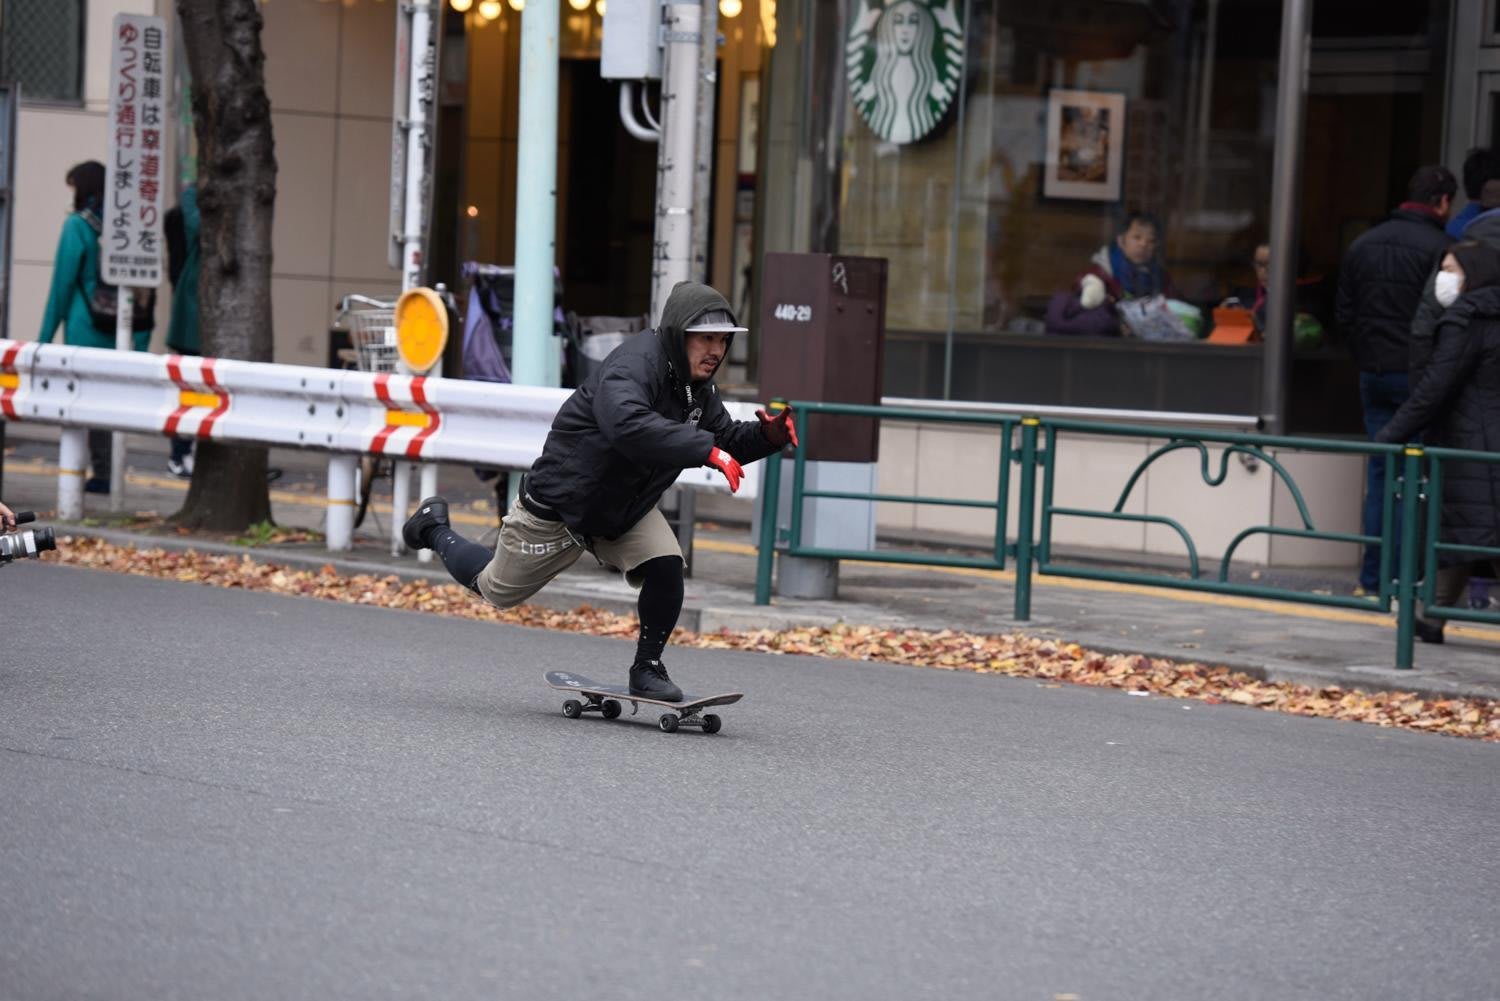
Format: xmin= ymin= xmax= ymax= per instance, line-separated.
xmin=48 ymin=539 xmax=1500 ymax=741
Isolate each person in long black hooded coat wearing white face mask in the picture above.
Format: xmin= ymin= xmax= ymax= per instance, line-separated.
xmin=1376 ymin=242 xmax=1500 ymax=642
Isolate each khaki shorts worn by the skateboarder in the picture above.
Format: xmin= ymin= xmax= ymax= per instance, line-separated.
xmin=476 ymin=498 xmax=683 ymax=608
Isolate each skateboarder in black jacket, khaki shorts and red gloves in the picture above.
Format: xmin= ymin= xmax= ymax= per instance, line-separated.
xmin=402 ymin=282 xmax=797 ymax=702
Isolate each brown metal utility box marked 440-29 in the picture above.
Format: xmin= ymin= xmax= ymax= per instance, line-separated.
xmin=759 ymin=254 xmax=885 ymax=462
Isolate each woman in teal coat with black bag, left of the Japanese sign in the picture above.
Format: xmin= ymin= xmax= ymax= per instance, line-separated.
xmin=36 ymin=161 xmax=152 ymax=494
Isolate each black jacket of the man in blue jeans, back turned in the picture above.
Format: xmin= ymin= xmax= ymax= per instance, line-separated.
xmin=1337 ymin=209 xmax=1451 ymax=372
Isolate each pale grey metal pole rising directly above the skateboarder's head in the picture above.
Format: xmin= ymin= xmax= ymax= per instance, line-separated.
xmin=651 ymin=3 xmax=702 ymax=324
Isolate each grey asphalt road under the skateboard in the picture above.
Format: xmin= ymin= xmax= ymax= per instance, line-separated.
xmin=0 ymin=563 xmax=1500 ymax=1001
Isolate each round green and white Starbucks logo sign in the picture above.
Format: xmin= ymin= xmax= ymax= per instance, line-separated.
xmin=845 ymin=0 xmax=963 ymax=143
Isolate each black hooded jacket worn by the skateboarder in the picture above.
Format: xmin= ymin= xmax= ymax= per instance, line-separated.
xmin=527 ymin=282 xmax=776 ymax=539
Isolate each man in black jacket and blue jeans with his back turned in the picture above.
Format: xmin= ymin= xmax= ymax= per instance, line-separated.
xmin=1337 ymin=167 xmax=1458 ymax=593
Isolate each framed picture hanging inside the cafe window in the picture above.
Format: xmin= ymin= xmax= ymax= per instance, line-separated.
xmin=1041 ymin=90 xmax=1125 ymax=201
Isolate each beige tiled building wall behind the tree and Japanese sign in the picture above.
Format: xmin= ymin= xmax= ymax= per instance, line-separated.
xmin=11 ymin=0 xmax=401 ymax=365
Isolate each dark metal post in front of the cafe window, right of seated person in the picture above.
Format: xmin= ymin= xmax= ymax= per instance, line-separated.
xmin=1260 ymin=0 xmax=1313 ymax=435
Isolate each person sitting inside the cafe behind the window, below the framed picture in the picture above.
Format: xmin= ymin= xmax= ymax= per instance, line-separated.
xmin=1046 ymin=212 xmax=1176 ymax=338
